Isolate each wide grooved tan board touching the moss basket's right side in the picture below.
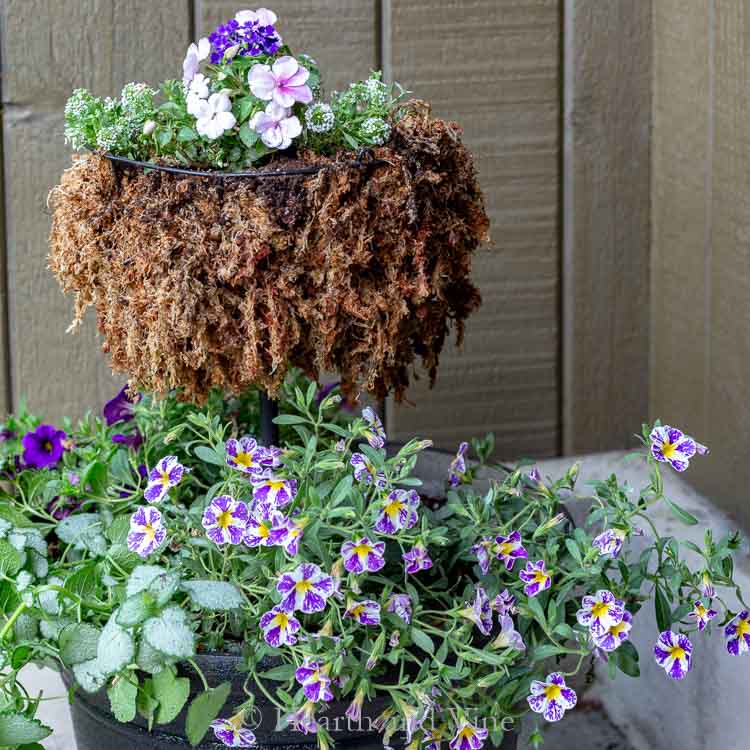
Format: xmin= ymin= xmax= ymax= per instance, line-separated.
xmin=384 ymin=0 xmax=560 ymax=456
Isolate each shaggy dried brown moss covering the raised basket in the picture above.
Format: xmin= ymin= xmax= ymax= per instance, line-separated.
xmin=50 ymin=103 xmax=488 ymax=401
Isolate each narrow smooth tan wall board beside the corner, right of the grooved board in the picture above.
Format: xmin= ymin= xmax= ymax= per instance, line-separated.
xmin=562 ymin=0 xmax=652 ymax=453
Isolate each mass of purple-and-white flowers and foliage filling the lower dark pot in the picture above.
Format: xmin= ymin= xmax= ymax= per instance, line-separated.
xmin=0 ymin=374 xmax=750 ymax=750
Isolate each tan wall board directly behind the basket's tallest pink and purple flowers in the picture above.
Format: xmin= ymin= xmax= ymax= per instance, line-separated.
xmin=196 ymin=0 xmax=378 ymax=91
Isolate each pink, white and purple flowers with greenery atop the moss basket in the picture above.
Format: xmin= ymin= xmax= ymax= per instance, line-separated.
xmin=65 ymin=8 xmax=404 ymax=169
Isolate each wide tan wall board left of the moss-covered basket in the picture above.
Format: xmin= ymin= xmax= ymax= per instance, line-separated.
xmin=2 ymin=0 xmax=190 ymax=419
